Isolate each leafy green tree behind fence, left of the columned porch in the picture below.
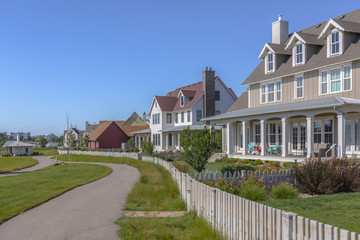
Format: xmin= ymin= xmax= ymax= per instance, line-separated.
xmin=180 ymin=126 xmax=216 ymax=172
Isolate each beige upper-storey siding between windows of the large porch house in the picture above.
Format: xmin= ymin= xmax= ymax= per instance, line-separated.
xmin=249 ymin=60 xmax=360 ymax=107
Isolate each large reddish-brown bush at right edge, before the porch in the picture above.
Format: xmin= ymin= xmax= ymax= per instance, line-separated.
xmin=291 ymin=159 xmax=360 ymax=194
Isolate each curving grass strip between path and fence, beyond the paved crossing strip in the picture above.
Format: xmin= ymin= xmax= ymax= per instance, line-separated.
xmin=58 ymin=155 xmax=186 ymax=211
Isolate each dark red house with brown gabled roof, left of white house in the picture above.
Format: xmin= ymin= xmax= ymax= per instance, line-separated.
xmin=88 ymin=112 xmax=149 ymax=149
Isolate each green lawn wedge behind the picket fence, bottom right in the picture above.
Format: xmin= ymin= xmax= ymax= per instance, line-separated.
xmin=262 ymin=193 xmax=360 ymax=233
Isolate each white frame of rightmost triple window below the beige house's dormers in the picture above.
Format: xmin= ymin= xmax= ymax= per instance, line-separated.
xmin=319 ymin=62 xmax=353 ymax=96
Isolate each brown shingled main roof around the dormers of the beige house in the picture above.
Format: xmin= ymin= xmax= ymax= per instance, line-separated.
xmin=242 ymin=9 xmax=360 ymax=85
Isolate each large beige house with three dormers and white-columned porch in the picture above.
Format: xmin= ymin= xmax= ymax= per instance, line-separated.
xmin=206 ymin=9 xmax=360 ymax=161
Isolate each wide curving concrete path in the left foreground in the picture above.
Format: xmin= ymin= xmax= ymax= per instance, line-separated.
xmin=0 ymin=164 xmax=140 ymax=240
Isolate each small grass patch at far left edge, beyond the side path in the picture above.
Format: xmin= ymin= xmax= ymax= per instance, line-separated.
xmin=0 ymin=156 xmax=39 ymax=173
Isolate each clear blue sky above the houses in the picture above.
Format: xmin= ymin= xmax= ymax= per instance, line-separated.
xmin=0 ymin=0 xmax=360 ymax=135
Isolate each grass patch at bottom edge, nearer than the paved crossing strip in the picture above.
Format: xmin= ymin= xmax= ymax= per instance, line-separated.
xmin=116 ymin=212 xmax=223 ymax=240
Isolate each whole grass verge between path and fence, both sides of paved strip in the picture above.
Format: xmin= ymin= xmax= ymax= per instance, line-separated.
xmin=59 ymin=155 xmax=223 ymax=240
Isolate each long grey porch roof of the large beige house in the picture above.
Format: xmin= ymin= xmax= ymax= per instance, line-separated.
xmin=202 ymin=97 xmax=360 ymax=121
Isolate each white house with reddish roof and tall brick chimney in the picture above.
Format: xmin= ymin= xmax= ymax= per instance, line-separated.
xmin=134 ymin=67 xmax=237 ymax=151
